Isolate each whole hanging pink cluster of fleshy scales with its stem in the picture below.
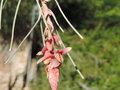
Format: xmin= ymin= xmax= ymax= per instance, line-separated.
xmin=37 ymin=0 xmax=71 ymax=90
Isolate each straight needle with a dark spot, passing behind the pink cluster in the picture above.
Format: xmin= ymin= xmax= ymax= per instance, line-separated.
xmin=56 ymin=30 xmax=84 ymax=79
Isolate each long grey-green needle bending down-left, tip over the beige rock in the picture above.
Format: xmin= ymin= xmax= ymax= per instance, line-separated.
xmin=5 ymin=0 xmax=41 ymax=64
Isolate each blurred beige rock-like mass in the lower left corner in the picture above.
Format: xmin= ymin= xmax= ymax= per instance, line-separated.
xmin=0 ymin=37 xmax=34 ymax=90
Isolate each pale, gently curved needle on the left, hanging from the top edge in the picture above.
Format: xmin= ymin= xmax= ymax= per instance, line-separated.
xmin=9 ymin=0 xmax=21 ymax=51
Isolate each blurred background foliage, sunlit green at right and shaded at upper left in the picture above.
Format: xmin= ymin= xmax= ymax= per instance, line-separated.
xmin=0 ymin=0 xmax=120 ymax=90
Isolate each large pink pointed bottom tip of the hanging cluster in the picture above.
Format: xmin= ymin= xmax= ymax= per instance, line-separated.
xmin=47 ymin=68 xmax=59 ymax=90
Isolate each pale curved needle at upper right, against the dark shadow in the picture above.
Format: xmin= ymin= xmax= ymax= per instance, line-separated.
xmin=55 ymin=0 xmax=83 ymax=39
